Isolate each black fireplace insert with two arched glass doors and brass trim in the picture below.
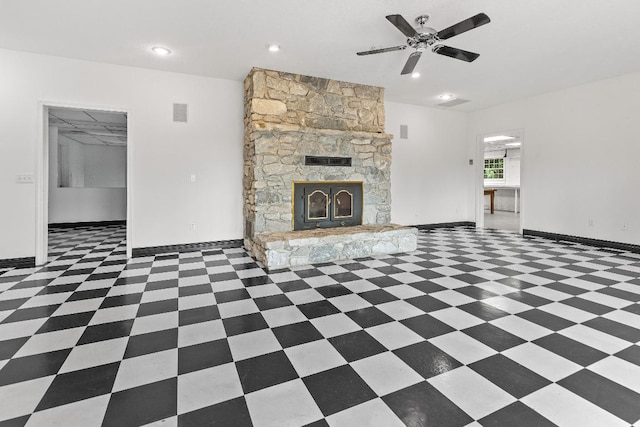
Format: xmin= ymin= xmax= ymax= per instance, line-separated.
xmin=292 ymin=181 xmax=363 ymax=230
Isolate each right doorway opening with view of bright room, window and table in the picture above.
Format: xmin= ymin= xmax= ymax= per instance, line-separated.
xmin=476 ymin=130 xmax=524 ymax=234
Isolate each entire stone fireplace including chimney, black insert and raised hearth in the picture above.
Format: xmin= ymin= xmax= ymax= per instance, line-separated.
xmin=243 ymin=68 xmax=416 ymax=268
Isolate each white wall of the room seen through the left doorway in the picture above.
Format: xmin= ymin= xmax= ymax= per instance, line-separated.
xmin=48 ymin=126 xmax=127 ymax=224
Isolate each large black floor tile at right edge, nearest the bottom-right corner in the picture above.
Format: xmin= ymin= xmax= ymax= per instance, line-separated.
xmin=558 ymin=369 xmax=640 ymax=423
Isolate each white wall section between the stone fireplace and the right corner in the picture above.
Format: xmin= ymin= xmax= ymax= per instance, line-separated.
xmin=385 ymin=102 xmax=474 ymax=225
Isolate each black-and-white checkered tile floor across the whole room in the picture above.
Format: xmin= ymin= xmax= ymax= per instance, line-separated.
xmin=0 ymin=226 xmax=640 ymax=427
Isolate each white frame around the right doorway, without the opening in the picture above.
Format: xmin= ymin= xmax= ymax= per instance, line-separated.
xmin=475 ymin=128 xmax=526 ymax=234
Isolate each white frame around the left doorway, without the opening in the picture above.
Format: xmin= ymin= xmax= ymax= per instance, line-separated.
xmin=35 ymin=100 xmax=133 ymax=265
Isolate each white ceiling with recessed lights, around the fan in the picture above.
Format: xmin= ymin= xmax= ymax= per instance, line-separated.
xmin=0 ymin=0 xmax=640 ymax=111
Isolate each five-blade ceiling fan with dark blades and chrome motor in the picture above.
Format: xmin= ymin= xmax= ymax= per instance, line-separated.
xmin=357 ymin=13 xmax=491 ymax=74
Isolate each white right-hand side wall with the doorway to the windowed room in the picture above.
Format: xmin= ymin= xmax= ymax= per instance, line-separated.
xmin=469 ymin=73 xmax=640 ymax=244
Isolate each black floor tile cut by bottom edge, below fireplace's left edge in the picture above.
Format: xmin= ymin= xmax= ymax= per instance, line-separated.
xmin=178 ymin=397 xmax=253 ymax=427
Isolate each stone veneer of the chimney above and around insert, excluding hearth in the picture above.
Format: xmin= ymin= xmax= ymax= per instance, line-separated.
xmin=243 ymin=68 xmax=392 ymax=252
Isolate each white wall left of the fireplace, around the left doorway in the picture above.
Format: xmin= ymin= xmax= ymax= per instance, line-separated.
xmin=0 ymin=50 xmax=244 ymax=259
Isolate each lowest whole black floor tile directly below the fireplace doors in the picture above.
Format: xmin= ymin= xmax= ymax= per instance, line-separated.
xmin=302 ymin=365 xmax=377 ymax=416
